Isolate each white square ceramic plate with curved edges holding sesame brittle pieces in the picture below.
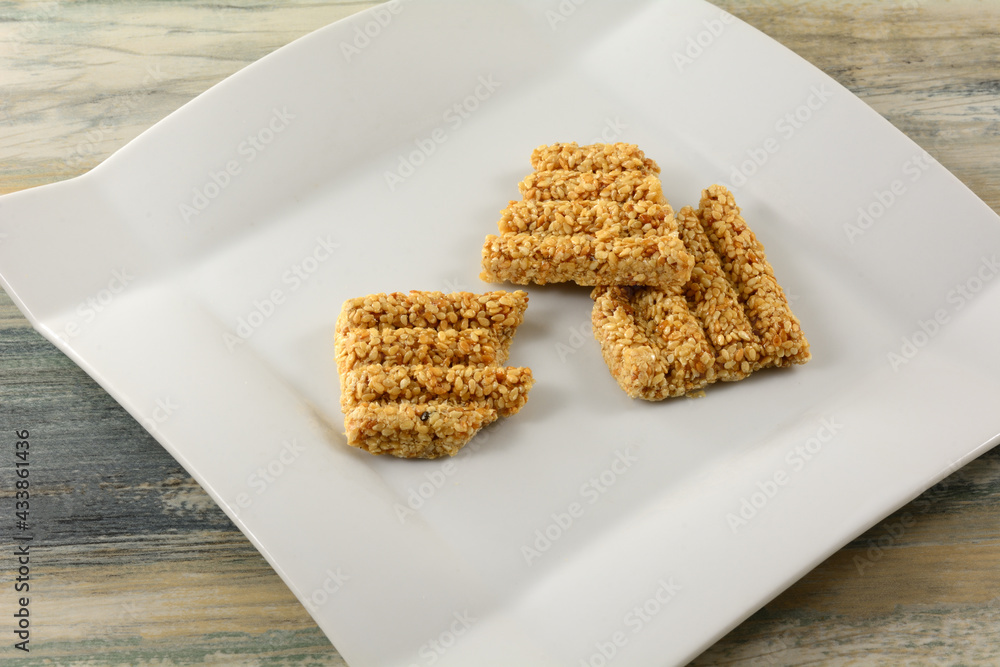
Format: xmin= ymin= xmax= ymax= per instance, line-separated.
xmin=0 ymin=0 xmax=1000 ymax=666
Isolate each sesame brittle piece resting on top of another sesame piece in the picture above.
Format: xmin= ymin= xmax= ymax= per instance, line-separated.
xmin=480 ymin=144 xmax=694 ymax=289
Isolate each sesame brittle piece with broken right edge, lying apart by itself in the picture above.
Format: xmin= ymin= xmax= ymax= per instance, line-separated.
xmin=335 ymin=291 xmax=533 ymax=458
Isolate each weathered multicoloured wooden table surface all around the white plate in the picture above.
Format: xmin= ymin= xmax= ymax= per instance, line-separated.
xmin=0 ymin=0 xmax=1000 ymax=666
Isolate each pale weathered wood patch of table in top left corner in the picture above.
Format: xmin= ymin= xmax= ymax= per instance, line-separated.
xmin=0 ymin=0 xmax=379 ymax=193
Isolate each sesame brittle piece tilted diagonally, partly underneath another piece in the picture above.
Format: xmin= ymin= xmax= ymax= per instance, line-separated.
xmin=592 ymin=186 xmax=810 ymax=400
